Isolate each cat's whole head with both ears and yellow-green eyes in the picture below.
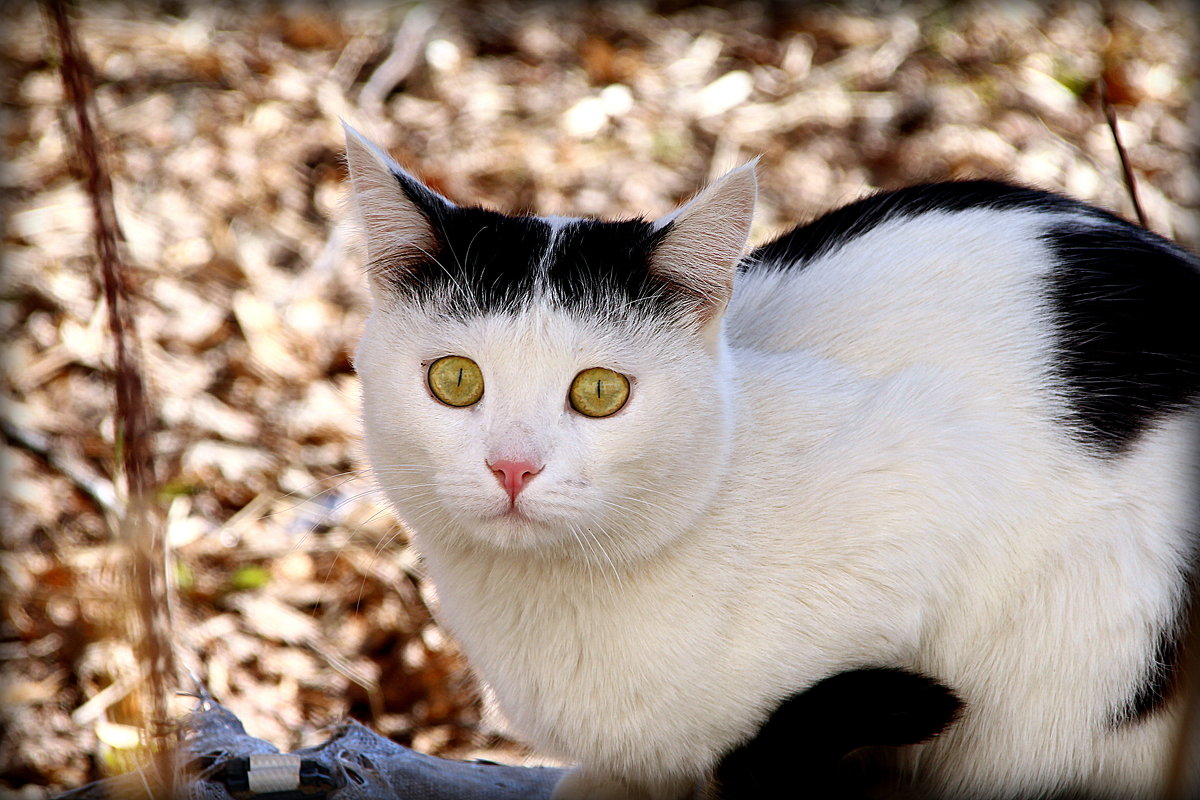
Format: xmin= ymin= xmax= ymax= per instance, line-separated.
xmin=347 ymin=128 xmax=755 ymax=566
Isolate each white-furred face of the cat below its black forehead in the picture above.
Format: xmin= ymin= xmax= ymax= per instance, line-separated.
xmin=356 ymin=298 xmax=727 ymax=559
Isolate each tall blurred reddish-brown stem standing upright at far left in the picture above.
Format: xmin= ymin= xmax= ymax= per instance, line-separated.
xmin=46 ymin=0 xmax=178 ymax=796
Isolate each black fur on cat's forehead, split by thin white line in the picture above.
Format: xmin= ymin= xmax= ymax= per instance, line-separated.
xmin=391 ymin=207 xmax=673 ymax=317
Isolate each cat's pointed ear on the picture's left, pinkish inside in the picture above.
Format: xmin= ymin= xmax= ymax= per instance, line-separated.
xmin=342 ymin=122 xmax=455 ymax=287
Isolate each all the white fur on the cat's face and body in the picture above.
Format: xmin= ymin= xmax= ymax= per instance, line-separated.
xmin=356 ymin=139 xmax=1190 ymax=800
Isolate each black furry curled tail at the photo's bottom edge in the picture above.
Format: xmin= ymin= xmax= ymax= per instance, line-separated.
xmin=715 ymin=668 xmax=962 ymax=800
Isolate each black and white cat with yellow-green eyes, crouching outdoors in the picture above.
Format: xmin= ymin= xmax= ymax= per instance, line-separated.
xmin=347 ymin=127 xmax=1200 ymax=800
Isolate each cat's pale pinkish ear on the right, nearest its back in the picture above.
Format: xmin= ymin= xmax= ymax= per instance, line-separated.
xmin=650 ymin=158 xmax=758 ymax=323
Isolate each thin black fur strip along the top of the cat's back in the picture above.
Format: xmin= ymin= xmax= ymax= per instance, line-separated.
xmin=743 ymin=180 xmax=1084 ymax=270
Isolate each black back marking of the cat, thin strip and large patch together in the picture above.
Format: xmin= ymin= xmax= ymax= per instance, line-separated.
xmin=742 ymin=180 xmax=1200 ymax=455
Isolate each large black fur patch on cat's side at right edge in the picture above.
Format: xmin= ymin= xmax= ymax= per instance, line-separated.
xmin=1045 ymin=223 xmax=1200 ymax=456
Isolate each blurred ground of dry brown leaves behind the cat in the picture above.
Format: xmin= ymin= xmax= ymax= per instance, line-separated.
xmin=0 ymin=0 xmax=1200 ymax=798
